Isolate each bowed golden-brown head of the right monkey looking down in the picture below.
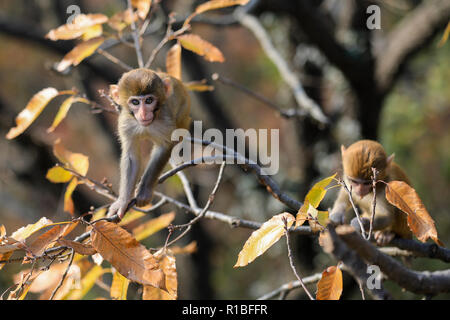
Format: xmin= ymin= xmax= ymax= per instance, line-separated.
xmin=341 ymin=140 xmax=394 ymax=198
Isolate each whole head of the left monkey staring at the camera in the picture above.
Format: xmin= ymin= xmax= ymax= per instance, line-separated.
xmin=116 ymin=68 xmax=170 ymax=127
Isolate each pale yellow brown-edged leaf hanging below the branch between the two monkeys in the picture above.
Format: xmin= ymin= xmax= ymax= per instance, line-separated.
xmin=234 ymin=212 xmax=295 ymax=268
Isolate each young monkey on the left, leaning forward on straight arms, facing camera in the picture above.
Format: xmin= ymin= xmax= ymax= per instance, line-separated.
xmin=108 ymin=68 xmax=191 ymax=218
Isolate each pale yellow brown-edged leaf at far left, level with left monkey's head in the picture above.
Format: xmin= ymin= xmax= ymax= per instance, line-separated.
xmin=6 ymin=88 xmax=59 ymax=139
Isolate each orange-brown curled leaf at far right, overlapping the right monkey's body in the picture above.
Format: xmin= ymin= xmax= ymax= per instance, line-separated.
xmin=386 ymin=181 xmax=444 ymax=246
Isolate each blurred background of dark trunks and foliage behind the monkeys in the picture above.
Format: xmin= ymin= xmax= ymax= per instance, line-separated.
xmin=0 ymin=0 xmax=450 ymax=299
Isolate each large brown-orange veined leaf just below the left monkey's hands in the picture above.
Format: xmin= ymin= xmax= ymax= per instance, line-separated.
xmin=91 ymin=221 xmax=165 ymax=289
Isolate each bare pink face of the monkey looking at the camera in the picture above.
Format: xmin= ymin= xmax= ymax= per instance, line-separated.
xmin=128 ymin=94 xmax=159 ymax=127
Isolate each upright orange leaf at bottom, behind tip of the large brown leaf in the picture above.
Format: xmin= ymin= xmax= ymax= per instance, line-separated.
xmin=142 ymin=249 xmax=178 ymax=300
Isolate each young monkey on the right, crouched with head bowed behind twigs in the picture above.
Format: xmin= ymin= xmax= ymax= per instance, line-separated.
xmin=330 ymin=140 xmax=412 ymax=245
